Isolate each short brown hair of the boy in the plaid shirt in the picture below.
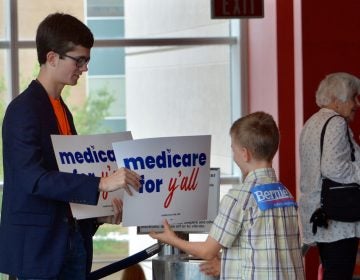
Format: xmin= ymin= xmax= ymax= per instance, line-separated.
xmin=230 ymin=112 xmax=280 ymax=162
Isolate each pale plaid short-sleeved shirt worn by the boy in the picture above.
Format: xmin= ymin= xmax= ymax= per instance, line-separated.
xmin=209 ymin=168 xmax=304 ymax=280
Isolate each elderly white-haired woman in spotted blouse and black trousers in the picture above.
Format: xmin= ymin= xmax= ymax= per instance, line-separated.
xmin=299 ymin=73 xmax=360 ymax=280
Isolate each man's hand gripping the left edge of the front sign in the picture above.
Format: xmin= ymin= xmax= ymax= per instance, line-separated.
xmin=99 ymin=167 xmax=141 ymax=195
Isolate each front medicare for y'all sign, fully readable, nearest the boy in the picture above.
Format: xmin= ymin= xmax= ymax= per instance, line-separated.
xmin=113 ymin=135 xmax=211 ymax=226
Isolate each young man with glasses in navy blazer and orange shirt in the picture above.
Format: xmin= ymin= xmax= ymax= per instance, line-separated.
xmin=0 ymin=13 xmax=140 ymax=280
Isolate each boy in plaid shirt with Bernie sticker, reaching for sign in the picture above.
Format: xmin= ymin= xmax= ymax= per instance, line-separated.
xmin=150 ymin=112 xmax=304 ymax=280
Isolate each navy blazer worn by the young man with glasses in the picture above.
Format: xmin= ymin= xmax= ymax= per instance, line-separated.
xmin=0 ymin=81 xmax=100 ymax=278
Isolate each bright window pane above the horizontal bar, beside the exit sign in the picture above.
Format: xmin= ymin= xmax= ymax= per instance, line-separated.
xmin=124 ymin=0 xmax=229 ymax=38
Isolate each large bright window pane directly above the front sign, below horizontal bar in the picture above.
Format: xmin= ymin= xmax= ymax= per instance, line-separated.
xmin=126 ymin=46 xmax=232 ymax=174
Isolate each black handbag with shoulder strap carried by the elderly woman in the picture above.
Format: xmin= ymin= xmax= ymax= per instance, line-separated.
xmin=310 ymin=115 xmax=360 ymax=234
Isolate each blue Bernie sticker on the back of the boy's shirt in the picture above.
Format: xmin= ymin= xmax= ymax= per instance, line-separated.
xmin=251 ymin=183 xmax=296 ymax=211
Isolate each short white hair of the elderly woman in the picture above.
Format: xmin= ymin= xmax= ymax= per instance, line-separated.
xmin=316 ymin=72 xmax=360 ymax=107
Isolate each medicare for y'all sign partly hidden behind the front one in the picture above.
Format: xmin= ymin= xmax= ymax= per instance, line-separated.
xmin=51 ymin=131 xmax=132 ymax=219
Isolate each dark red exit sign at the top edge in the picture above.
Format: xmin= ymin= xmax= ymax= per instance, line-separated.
xmin=211 ymin=0 xmax=264 ymax=18
